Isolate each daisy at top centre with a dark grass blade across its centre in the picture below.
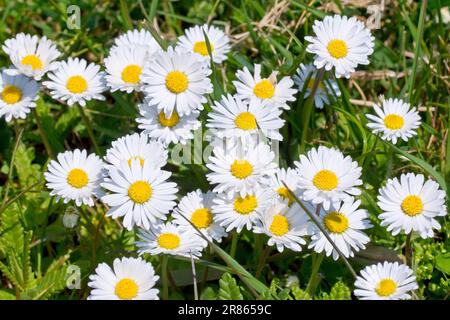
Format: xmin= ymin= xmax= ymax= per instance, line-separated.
xmin=177 ymin=24 xmax=230 ymax=63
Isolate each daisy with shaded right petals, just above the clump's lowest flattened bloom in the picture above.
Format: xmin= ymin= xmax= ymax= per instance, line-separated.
xmin=172 ymin=189 xmax=227 ymax=246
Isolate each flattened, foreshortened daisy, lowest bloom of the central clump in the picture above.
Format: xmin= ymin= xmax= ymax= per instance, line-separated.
xmin=136 ymin=222 xmax=204 ymax=259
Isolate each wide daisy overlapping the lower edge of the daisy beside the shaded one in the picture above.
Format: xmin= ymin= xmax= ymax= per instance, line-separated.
xmin=206 ymin=95 xmax=284 ymax=141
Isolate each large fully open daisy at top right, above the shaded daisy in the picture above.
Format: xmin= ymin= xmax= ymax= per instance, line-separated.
xmin=305 ymin=15 xmax=375 ymax=78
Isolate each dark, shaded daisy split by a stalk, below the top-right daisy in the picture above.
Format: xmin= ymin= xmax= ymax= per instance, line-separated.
xmin=294 ymin=63 xmax=341 ymax=109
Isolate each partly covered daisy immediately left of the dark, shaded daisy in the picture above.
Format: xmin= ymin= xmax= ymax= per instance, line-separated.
xmin=233 ymin=64 xmax=297 ymax=110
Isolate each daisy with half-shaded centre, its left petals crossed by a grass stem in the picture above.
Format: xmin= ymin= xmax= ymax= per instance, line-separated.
xmin=308 ymin=200 xmax=372 ymax=260
